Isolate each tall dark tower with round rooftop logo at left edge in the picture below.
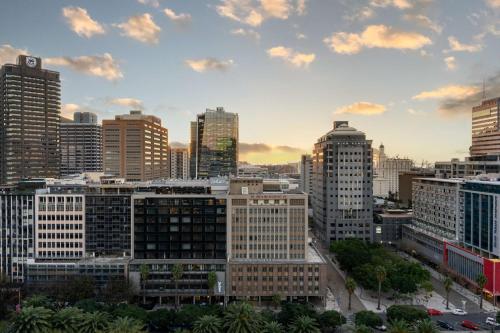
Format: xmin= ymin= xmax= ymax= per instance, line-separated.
xmin=0 ymin=55 xmax=61 ymax=184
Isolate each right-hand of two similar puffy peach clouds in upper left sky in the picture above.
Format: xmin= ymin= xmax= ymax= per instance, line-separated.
xmin=115 ymin=13 xmax=161 ymax=44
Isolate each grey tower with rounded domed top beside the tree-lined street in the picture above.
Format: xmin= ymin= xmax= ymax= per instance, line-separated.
xmin=311 ymin=121 xmax=373 ymax=244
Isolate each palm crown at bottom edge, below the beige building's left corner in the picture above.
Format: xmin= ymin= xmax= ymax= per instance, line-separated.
xmin=224 ymin=302 xmax=262 ymax=333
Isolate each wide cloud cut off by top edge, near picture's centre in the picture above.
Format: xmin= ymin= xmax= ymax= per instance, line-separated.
xmin=216 ymin=0 xmax=306 ymax=27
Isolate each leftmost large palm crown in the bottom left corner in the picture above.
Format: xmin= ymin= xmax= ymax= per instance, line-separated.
xmin=9 ymin=306 xmax=53 ymax=333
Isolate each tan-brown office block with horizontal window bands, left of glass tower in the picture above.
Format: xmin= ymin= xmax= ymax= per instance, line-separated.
xmin=102 ymin=110 xmax=170 ymax=181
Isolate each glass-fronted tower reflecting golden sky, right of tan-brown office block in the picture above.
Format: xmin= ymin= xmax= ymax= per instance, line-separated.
xmin=191 ymin=107 xmax=238 ymax=178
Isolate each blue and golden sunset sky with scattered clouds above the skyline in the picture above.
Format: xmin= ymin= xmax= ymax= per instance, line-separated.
xmin=0 ymin=0 xmax=500 ymax=165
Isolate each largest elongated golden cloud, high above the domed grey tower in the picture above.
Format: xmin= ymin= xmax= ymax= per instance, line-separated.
xmin=323 ymin=24 xmax=432 ymax=54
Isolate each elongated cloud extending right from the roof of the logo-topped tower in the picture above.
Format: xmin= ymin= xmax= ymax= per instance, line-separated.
xmin=44 ymin=53 xmax=123 ymax=81
